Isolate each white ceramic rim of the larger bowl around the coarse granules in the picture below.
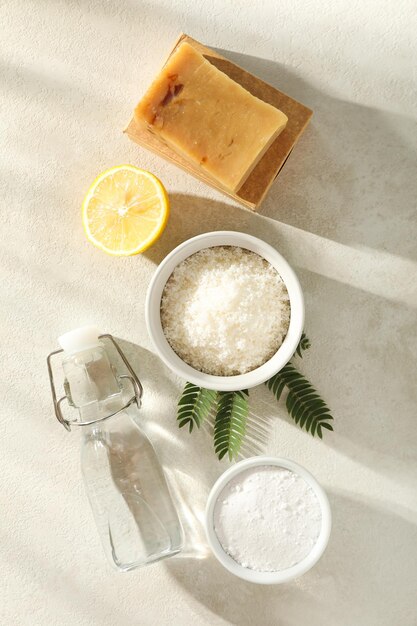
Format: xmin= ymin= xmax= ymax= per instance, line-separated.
xmin=145 ymin=231 xmax=304 ymax=391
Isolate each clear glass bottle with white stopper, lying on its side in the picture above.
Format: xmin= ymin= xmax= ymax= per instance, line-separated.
xmin=59 ymin=327 xmax=183 ymax=571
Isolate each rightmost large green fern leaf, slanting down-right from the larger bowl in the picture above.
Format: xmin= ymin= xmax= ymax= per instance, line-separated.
xmin=266 ymin=360 xmax=333 ymax=439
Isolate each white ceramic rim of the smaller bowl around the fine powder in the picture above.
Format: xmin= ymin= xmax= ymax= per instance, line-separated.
xmin=206 ymin=456 xmax=332 ymax=585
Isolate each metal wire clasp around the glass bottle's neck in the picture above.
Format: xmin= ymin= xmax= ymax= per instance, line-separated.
xmin=46 ymin=334 xmax=143 ymax=430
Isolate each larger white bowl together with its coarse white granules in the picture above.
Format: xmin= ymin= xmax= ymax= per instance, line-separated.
xmin=145 ymin=231 xmax=304 ymax=391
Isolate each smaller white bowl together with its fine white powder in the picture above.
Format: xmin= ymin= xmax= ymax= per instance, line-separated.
xmin=206 ymin=456 xmax=331 ymax=584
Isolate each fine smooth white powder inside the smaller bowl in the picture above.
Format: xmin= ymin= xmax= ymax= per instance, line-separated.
xmin=214 ymin=465 xmax=321 ymax=572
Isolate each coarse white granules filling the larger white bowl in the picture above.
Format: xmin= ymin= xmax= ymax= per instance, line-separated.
xmin=161 ymin=246 xmax=290 ymax=376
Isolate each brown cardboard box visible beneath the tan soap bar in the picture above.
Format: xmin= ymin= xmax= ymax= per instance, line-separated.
xmin=124 ymin=34 xmax=313 ymax=211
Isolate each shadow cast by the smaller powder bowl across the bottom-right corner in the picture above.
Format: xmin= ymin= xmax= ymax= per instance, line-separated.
xmin=165 ymin=492 xmax=417 ymax=626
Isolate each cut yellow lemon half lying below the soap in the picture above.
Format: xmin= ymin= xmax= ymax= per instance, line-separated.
xmin=82 ymin=165 xmax=169 ymax=256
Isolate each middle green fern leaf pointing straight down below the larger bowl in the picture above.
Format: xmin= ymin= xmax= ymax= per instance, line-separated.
xmin=214 ymin=390 xmax=249 ymax=460
